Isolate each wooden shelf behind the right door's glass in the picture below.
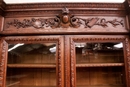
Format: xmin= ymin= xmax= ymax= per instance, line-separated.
xmin=76 ymin=63 xmax=124 ymax=67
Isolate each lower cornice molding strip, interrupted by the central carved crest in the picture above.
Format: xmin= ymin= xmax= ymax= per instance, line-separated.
xmin=4 ymin=9 xmax=126 ymax=17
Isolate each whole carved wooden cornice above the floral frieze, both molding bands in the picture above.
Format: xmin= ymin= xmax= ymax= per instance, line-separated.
xmin=5 ymin=3 xmax=125 ymax=17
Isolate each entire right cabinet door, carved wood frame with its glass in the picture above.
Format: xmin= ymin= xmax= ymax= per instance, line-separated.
xmin=66 ymin=35 xmax=130 ymax=87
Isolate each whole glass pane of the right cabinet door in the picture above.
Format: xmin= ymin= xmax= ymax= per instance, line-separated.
xmin=75 ymin=42 xmax=126 ymax=87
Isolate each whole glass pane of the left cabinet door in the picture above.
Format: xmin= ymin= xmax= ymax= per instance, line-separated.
xmin=6 ymin=43 xmax=56 ymax=87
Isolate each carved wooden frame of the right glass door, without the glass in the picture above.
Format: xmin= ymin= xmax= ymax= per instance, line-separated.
xmin=69 ymin=35 xmax=130 ymax=87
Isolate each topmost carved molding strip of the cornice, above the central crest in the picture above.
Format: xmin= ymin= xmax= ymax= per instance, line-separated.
xmin=6 ymin=3 xmax=124 ymax=10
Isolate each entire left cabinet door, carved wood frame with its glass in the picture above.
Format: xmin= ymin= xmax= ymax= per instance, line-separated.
xmin=0 ymin=36 xmax=64 ymax=87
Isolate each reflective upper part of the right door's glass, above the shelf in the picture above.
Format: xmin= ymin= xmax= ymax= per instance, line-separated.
xmin=75 ymin=43 xmax=124 ymax=63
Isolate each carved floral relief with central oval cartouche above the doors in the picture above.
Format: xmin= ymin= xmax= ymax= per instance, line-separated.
xmin=6 ymin=8 xmax=124 ymax=29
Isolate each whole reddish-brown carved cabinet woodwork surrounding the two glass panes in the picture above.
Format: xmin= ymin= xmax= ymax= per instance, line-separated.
xmin=0 ymin=0 xmax=130 ymax=87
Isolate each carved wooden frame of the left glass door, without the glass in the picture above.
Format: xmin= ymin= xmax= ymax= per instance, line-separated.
xmin=1 ymin=36 xmax=64 ymax=87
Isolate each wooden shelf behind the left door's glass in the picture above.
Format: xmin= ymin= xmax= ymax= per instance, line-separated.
xmin=7 ymin=63 xmax=56 ymax=68
